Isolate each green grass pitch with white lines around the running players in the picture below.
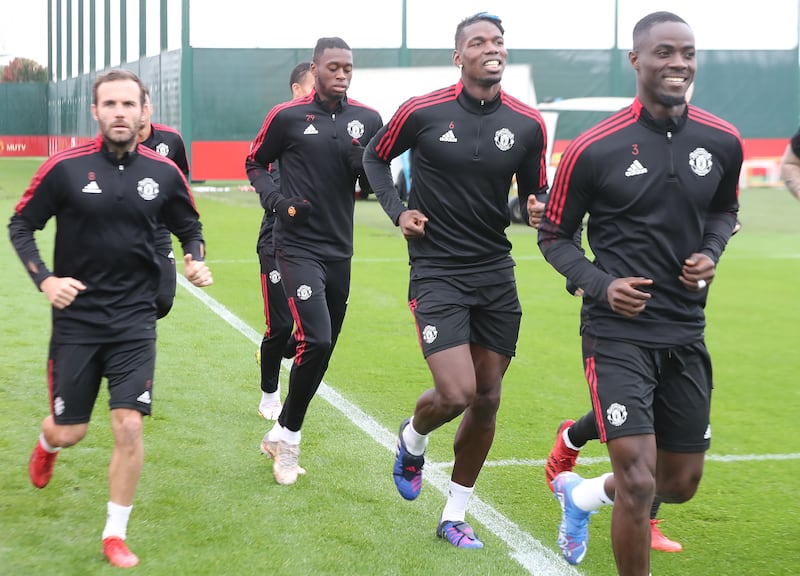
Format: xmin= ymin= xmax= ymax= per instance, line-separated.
xmin=0 ymin=159 xmax=800 ymax=576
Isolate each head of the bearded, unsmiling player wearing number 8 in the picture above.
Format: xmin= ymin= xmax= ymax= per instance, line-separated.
xmin=92 ymin=80 xmax=142 ymax=155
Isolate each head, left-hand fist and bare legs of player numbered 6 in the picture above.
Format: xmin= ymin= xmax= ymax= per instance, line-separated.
xmin=398 ymin=20 xmax=511 ymax=487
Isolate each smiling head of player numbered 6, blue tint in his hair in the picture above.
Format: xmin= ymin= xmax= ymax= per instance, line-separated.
xmin=453 ymin=20 xmax=508 ymax=93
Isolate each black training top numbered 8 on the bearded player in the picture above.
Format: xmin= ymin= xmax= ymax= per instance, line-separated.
xmin=9 ymin=135 xmax=204 ymax=343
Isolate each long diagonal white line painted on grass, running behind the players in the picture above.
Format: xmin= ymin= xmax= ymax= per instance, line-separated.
xmin=178 ymin=274 xmax=580 ymax=576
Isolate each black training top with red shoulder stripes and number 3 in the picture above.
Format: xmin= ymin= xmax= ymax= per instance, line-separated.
xmin=539 ymin=98 xmax=743 ymax=347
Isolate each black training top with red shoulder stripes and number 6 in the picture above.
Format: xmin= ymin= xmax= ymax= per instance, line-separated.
xmin=364 ymin=81 xmax=547 ymax=277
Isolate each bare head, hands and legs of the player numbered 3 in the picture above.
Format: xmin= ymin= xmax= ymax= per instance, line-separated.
xmin=605 ymin=22 xmax=714 ymax=576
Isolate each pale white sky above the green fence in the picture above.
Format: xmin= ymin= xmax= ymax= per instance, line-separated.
xmin=0 ymin=0 xmax=798 ymax=68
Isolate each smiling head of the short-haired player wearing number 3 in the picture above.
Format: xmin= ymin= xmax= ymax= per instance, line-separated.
xmin=628 ymin=22 xmax=697 ymax=118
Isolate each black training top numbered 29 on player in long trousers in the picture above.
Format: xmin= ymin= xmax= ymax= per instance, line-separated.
xmin=245 ymin=91 xmax=382 ymax=260
